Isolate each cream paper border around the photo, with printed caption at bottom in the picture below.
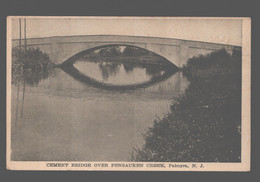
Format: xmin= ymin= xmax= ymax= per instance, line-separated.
xmin=6 ymin=16 xmax=251 ymax=171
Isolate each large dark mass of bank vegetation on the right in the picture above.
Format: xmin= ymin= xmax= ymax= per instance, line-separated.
xmin=132 ymin=50 xmax=241 ymax=162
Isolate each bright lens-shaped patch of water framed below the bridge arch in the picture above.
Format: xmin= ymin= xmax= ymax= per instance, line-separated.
xmin=74 ymin=59 xmax=168 ymax=85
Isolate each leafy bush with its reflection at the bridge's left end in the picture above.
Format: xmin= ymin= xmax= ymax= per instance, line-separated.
xmin=12 ymin=48 xmax=55 ymax=85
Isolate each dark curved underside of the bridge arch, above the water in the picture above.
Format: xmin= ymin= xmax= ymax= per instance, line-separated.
xmin=61 ymin=43 xmax=178 ymax=67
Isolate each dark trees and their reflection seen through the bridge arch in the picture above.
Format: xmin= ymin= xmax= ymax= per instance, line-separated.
xmin=80 ymin=46 xmax=176 ymax=80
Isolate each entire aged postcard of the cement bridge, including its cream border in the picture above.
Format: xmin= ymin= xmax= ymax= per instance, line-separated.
xmin=6 ymin=16 xmax=251 ymax=171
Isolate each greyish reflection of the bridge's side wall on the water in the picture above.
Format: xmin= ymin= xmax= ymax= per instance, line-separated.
xmin=15 ymin=71 xmax=188 ymax=99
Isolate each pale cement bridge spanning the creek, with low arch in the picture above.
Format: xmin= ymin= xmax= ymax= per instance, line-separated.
xmin=12 ymin=35 xmax=241 ymax=67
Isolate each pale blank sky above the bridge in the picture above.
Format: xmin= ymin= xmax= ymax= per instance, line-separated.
xmin=12 ymin=17 xmax=242 ymax=46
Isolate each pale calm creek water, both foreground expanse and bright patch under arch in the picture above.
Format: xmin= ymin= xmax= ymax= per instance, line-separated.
xmin=12 ymin=56 xmax=188 ymax=161
